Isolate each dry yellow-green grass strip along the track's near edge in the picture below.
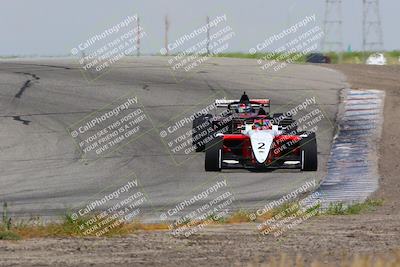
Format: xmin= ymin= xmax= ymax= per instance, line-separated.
xmin=0 ymin=200 xmax=382 ymax=240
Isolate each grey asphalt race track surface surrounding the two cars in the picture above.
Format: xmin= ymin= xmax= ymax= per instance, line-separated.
xmin=0 ymin=57 xmax=347 ymax=223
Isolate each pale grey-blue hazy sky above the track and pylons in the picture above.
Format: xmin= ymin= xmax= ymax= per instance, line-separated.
xmin=0 ymin=0 xmax=400 ymax=56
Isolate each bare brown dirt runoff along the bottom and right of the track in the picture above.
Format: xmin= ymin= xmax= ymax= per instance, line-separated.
xmin=0 ymin=65 xmax=400 ymax=266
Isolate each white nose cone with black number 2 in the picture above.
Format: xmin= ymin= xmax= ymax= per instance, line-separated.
xmin=249 ymin=130 xmax=275 ymax=163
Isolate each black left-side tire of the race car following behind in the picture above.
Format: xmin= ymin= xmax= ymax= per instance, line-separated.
xmin=192 ymin=114 xmax=212 ymax=152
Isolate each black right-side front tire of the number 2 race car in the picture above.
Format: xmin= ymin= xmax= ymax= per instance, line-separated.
xmin=300 ymin=133 xmax=318 ymax=171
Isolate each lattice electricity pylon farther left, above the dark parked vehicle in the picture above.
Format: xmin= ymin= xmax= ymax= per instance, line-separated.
xmin=322 ymin=0 xmax=343 ymax=52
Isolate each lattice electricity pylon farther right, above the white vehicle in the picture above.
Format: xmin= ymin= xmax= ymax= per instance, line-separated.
xmin=363 ymin=0 xmax=383 ymax=51
